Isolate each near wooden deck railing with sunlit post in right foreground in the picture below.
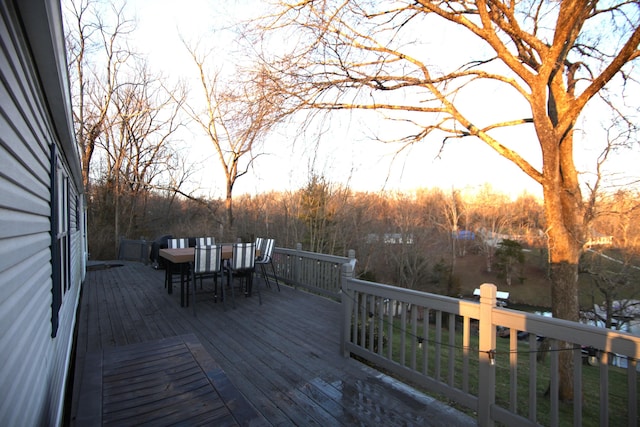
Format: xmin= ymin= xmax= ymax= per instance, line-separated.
xmin=341 ymin=264 xmax=640 ymax=426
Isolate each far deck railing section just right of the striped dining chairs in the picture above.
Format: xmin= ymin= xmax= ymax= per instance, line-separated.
xmin=267 ymin=243 xmax=356 ymax=300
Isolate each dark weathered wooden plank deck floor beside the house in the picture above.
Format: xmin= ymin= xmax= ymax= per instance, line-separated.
xmin=69 ymin=262 xmax=475 ymax=426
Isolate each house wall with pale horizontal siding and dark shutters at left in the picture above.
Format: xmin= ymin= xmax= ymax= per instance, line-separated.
xmin=0 ymin=0 xmax=86 ymax=426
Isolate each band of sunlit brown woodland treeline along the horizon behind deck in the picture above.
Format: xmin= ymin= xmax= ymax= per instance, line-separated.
xmin=88 ymin=177 xmax=640 ymax=295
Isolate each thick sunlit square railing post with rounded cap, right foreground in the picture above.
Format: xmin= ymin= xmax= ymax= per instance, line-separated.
xmin=478 ymin=283 xmax=497 ymax=427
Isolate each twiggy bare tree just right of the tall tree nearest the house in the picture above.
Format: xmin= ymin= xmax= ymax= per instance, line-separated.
xmin=98 ymin=59 xmax=184 ymax=247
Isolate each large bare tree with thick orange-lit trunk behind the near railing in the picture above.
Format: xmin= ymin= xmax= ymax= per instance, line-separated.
xmin=255 ymin=0 xmax=640 ymax=400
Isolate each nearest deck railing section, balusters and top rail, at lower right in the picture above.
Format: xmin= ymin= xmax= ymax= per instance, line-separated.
xmin=342 ymin=264 xmax=640 ymax=426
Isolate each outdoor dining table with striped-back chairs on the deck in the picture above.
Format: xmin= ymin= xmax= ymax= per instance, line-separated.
xmin=158 ymin=237 xmax=280 ymax=314
